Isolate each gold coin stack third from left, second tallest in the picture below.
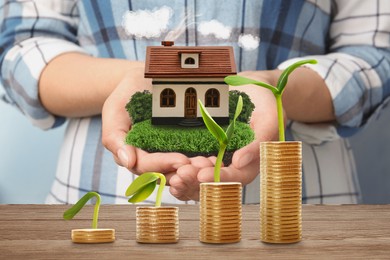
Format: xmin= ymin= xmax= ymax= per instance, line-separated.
xmin=199 ymin=182 xmax=242 ymax=244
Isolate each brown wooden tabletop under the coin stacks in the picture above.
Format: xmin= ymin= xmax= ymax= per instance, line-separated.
xmin=0 ymin=205 xmax=390 ymax=260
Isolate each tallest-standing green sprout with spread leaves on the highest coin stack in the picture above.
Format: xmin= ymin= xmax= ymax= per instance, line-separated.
xmin=225 ymin=60 xmax=317 ymax=142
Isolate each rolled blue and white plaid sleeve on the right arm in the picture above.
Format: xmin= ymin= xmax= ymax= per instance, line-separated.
xmin=279 ymin=0 xmax=390 ymax=135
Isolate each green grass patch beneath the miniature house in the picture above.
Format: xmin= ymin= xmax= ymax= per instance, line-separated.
xmin=126 ymin=120 xmax=254 ymax=154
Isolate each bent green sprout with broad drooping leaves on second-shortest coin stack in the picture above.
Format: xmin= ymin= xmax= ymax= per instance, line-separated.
xmin=126 ymin=172 xmax=166 ymax=207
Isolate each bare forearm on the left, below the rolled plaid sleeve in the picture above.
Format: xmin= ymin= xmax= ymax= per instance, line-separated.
xmin=39 ymin=53 xmax=144 ymax=117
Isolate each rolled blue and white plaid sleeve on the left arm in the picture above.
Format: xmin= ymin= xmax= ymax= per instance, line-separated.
xmin=0 ymin=0 xmax=85 ymax=129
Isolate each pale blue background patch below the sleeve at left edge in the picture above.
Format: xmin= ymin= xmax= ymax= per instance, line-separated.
xmin=0 ymin=86 xmax=65 ymax=204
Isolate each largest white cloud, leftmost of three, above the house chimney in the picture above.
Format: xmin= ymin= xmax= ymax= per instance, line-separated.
xmin=122 ymin=6 xmax=173 ymax=38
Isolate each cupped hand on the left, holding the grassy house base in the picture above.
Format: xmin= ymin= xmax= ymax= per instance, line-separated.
xmin=102 ymin=66 xmax=190 ymax=178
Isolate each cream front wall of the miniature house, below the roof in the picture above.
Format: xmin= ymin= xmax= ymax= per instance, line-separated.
xmin=152 ymin=80 xmax=229 ymax=117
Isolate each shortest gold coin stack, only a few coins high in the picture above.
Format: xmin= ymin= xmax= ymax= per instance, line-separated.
xmin=72 ymin=228 xmax=115 ymax=244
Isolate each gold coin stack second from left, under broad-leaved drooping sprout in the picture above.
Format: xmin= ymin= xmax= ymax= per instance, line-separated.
xmin=136 ymin=207 xmax=179 ymax=244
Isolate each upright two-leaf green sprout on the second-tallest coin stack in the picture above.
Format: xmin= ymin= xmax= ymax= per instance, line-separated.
xmin=198 ymin=96 xmax=243 ymax=182
